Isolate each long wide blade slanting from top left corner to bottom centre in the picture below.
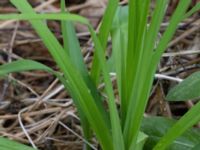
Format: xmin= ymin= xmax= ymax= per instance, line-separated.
xmin=9 ymin=0 xmax=113 ymax=149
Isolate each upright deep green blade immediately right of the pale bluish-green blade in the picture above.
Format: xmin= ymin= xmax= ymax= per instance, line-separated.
xmin=121 ymin=0 xmax=139 ymax=131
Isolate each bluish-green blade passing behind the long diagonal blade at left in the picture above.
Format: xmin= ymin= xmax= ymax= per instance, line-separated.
xmin=61 ymin=0 xmax=93 ymax=144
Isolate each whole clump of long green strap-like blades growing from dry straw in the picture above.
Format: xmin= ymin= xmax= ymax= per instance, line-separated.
xmin=0 ymin=0 xmax=200 ymax=150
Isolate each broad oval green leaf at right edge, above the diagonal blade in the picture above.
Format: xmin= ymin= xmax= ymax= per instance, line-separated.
xmin=166 ymin=72 xmax=200 ymax=101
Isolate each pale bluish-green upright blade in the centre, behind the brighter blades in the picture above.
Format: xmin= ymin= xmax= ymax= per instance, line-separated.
xmin=111 ymin=7 xmax=128 ymax=125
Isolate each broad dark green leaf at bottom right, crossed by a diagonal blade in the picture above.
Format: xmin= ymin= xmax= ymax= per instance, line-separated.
xmin=141 ymin=117 xmax=200 ymax=150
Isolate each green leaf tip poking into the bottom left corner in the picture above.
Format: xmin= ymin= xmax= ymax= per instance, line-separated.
xmin=0 ymin=137 xmax=36 ymax=150
